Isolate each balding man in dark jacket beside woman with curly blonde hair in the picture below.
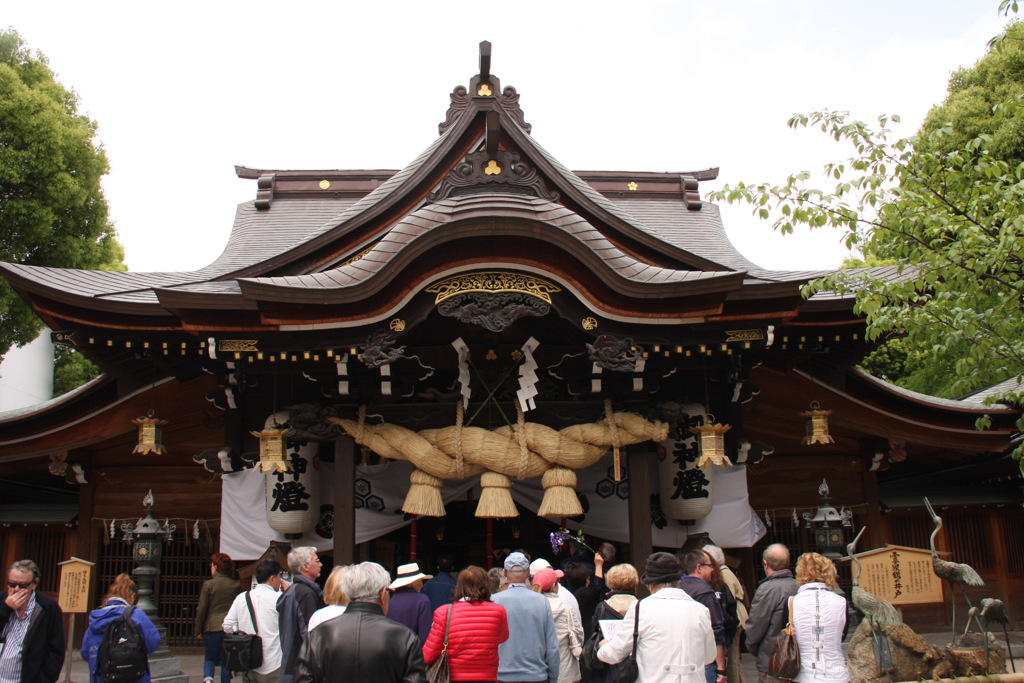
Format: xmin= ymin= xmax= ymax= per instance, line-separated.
xmin=745 ymin=543 xmax=797 ymax=683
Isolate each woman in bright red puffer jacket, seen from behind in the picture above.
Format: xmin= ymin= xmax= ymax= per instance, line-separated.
xmin=423 ymin=566 xmax=509 ymax=681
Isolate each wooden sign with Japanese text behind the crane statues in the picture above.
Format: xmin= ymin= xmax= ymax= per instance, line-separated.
xmin=853 ymin=546 xmax=942 ymax=605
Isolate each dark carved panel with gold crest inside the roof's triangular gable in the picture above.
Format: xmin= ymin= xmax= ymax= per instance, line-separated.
xmin=427 ymin=150 xmax=558 ymax=202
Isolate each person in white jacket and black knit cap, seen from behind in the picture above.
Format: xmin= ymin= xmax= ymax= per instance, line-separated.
xmin=597 ymin=553 xmax=716 ymax=683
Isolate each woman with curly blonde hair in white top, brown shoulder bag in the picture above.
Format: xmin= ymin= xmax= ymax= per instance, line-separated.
xmin=793 ymin=553 xmax=850 ymax=683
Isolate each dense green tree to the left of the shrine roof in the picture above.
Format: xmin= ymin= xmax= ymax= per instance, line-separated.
xmin=0 ymin=29 xmax=126 ymax=357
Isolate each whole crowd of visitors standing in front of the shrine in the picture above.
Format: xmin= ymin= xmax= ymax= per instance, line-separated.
xmin=0 ymin=544 xmax=850 ymax=683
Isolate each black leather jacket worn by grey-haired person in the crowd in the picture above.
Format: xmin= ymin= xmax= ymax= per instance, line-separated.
xmin=295 ymin=602 xmax=427 ymax=683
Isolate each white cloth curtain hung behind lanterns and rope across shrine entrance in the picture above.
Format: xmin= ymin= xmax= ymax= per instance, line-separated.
xmin=220 ymin=453 xmax=765 ymax=559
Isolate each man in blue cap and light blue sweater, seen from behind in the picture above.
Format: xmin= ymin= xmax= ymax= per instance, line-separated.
xmin=492 ymin=553 xmax=559 ymax=683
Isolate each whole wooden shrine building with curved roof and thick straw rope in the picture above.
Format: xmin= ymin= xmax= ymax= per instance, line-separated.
xmin=0 ymin=43 xmax=1024 ymax=645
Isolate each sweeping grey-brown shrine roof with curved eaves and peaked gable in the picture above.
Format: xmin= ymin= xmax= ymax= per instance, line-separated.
xmin=0 ymin=44 xmax=884 ymax=333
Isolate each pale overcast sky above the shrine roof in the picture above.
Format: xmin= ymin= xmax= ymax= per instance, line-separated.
xmin=0 ymin=0 xmax=1002 ymax=270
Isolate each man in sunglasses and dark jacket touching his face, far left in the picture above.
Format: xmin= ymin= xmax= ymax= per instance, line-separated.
xmin=0 ymin=560 xmax=65 ymax=683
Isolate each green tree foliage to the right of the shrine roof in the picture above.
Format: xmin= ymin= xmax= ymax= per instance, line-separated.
xmin=712 ymin=108 xmax=1024 ymax=454
